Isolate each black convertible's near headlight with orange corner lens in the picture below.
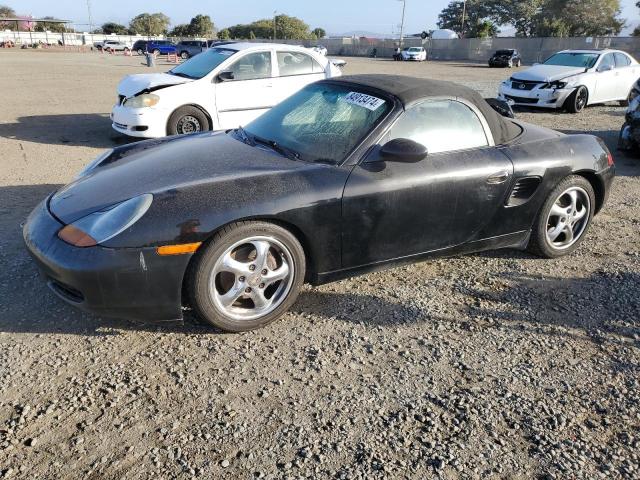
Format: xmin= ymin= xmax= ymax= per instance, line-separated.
xmin=58 ymin=193 xmax=153 ymax=247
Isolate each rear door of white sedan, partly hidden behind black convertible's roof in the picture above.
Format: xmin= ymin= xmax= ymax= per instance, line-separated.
xmin=274 ymin=50 xmax=325 ymax=103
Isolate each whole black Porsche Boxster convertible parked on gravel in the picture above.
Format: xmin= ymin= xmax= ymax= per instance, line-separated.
xmin=24 ymin=75 xmax=614 ymax=331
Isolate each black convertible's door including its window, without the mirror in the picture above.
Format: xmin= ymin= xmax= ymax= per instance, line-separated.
xmin=343 ymin=99 xmax=513 ymax=268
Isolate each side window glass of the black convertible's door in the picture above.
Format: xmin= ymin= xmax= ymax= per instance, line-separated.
xmin=389 ymin=100 xmax=489 ymax=153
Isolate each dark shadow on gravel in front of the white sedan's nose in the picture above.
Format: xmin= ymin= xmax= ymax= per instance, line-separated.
xmin=0 ymin=113 xmax=137 ymax=148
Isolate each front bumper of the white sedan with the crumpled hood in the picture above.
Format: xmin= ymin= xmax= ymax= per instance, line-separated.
xmin=111 ymin=105 xmax=168 ymax=138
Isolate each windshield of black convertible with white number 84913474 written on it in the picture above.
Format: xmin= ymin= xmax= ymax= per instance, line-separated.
xmin=240 ymin=83 xmax=391 ymax=165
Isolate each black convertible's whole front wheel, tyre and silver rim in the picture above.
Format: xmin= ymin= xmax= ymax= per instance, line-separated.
xmin=188 ymin=222 xmax=305 ymax=332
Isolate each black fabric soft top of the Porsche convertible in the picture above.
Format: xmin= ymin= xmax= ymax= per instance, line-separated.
xmin=330 ymin=74 xmax=522 ymax=145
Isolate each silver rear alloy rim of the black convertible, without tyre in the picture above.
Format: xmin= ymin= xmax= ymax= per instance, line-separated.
xmin=546 ymin=187 xmax=591 ymax=250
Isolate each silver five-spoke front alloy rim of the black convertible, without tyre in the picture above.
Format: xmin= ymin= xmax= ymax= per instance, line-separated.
xmin=209 ymin=236 xmax=295 ymax=320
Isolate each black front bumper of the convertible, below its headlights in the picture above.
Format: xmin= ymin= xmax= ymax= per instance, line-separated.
xmin=23 ymin=199 xmax=191 ymax=321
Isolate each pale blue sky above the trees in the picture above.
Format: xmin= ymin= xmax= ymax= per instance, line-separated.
xmin=5 ymin=0 xmax=640 ymax=35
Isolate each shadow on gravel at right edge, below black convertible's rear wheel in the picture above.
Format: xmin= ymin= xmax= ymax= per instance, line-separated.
xmin=460 ymin=272 xmax=640 ymax=343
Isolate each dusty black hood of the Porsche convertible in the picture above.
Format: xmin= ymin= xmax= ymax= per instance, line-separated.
xmin=49 ymin=132 xmax=314 ymax=224
